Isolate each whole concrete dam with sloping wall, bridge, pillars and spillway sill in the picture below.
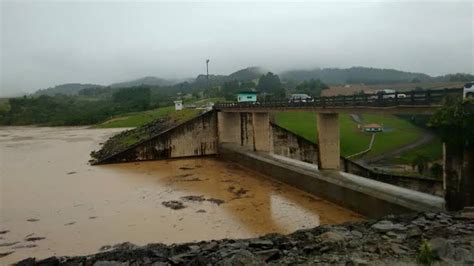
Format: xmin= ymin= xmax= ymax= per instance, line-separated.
xmin=92 ymin=90 xmax=470 ymax=217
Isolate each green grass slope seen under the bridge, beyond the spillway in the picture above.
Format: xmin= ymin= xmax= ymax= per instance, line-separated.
xmin=275 ymin=112 xmax=422 ymax=156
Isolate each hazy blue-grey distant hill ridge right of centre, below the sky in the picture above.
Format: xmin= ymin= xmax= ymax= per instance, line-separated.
xmin=280 ymin=67 xmax=434 ymax=84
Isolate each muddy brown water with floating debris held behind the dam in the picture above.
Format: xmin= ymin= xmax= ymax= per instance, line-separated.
xmin=0 ymin=127 xmax=362 ymax=265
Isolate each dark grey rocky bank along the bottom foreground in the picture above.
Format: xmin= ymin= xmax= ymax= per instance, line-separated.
xmin=16 ymin=209 xmax=474 ymax=266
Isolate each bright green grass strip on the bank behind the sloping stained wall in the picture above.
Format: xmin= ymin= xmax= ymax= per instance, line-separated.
xmin=94 ymin=106 xmax=201 ymax=128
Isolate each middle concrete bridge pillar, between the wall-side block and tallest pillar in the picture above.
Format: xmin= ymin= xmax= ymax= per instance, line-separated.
xmin=252 ymin=113 xmax=272 ymax=152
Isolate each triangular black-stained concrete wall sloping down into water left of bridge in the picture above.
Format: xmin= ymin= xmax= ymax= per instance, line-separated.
xmin=102 ymin=112 xmax=217 ymax=163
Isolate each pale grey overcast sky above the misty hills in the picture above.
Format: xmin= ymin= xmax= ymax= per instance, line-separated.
xmin=0 ymin=0 xmax=474 ymax=95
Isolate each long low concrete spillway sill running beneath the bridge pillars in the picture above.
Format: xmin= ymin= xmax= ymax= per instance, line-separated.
xmin=219 ymin=143 xmax=444 ymax=218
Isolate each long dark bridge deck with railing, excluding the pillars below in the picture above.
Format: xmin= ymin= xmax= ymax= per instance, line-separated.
xmin=214 ymin=88 xmax=463 ymax=110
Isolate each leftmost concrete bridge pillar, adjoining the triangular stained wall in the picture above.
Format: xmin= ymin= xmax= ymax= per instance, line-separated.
xmin=217 ymin=112 xmax=240 ymax=144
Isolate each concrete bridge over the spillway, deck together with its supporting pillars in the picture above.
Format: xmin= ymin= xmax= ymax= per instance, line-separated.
xmin=214 ymin=89 xmax=462 ymax=170
